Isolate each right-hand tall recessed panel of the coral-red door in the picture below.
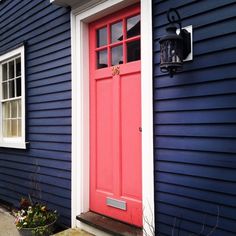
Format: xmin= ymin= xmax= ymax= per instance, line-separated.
xmin=121 ymin=73 xmax=142 ymax=200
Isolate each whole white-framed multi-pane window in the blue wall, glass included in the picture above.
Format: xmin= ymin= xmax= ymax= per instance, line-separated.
xmin=0 ymin=46 xmax=26 ymax=148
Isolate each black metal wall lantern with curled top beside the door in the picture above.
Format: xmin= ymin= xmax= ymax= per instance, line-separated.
xmin=159 ymin=8 xmax=191 ymax=77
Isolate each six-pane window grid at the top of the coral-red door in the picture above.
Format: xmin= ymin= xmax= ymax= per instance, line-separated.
xmin=95 ymin=14 xmax=140 ymax=69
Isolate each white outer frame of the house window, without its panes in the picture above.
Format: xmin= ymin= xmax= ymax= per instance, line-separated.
xmin=0 ymin=45 xmax=26 ymax=149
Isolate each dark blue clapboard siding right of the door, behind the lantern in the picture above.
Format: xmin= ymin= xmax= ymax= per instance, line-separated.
xmin=153 ymin=0 xmax=236 ymax=236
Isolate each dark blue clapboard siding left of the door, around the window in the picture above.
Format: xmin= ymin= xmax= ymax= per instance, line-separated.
xmin=0 ymin=0 xmax=71 ymax=225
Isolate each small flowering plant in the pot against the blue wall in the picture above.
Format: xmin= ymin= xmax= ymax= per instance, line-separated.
xmin=13 ymin=198 xmax=58 ymax=235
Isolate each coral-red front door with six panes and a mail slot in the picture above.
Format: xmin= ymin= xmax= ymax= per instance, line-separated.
xmin=89 ymin=5 xmax=142 ymax=226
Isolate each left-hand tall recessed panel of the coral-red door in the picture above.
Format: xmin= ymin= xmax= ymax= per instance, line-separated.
xmin=96 ymin=79 xmax=113 ymax=192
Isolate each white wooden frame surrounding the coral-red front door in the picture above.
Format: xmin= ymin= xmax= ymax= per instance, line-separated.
xmin=71 ymin=0 xmax=155 ymax=235
